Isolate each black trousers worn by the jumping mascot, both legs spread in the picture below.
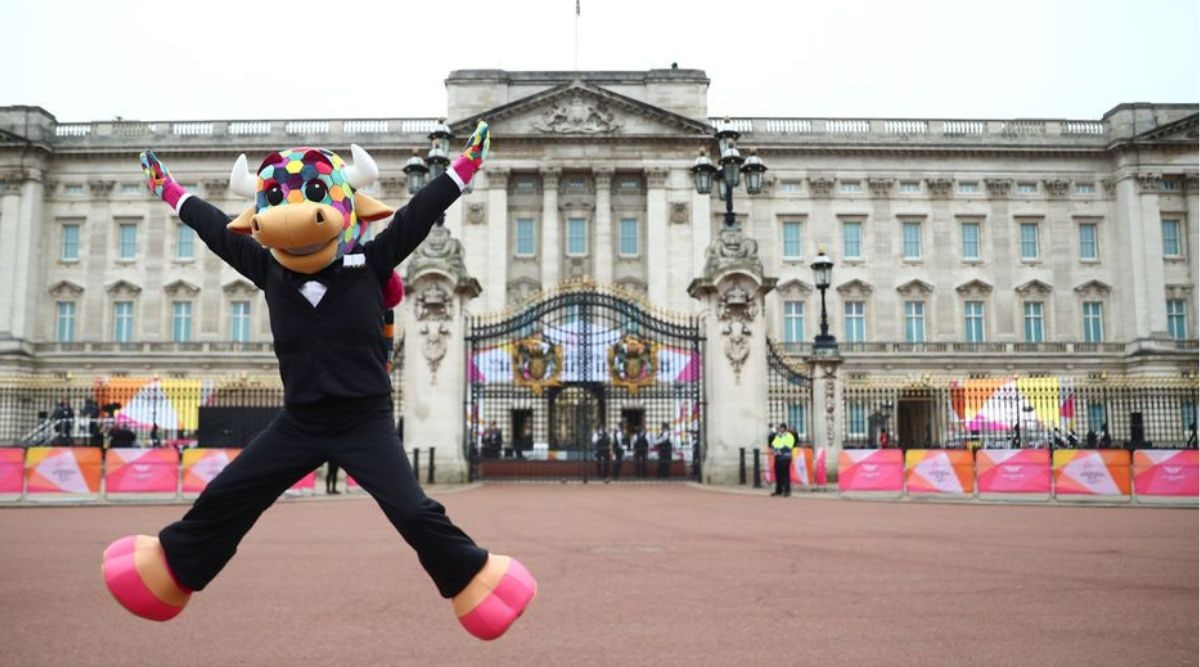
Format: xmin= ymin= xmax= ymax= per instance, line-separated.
xmin=158 ymin=397 xmax=487 ymax=597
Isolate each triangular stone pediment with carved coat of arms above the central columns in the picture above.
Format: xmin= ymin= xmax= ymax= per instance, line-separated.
xmin=451 ymin=82 xmax=712 ymax=137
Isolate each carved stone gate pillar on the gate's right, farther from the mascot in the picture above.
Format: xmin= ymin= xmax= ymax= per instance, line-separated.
xmin=688 ymin=227 xmax=775 ymax=483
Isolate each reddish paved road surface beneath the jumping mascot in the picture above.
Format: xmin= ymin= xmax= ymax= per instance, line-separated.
xmin=0 ymin=485 xmax=1198 ymax=667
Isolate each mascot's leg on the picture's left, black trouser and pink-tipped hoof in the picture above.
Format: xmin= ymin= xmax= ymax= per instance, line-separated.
xmin=102 ymin=415 xmax=324 ymax=620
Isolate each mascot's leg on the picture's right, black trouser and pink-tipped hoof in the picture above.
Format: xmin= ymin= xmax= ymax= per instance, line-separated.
xmin=331 ymin=413 xmax=538 ymax=639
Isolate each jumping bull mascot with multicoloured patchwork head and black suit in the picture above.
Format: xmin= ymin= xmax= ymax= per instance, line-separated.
xmin=102 ymin=122 xmax=536 ymax=639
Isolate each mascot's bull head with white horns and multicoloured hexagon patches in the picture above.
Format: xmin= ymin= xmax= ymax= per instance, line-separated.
xmin=229 ymin=145 xmax=392 ymax=274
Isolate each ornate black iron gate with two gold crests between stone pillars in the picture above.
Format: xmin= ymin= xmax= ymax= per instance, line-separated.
xmin=464 ymin=283 xmax=704 ymax=481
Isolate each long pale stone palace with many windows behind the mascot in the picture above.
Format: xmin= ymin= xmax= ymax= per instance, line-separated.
xmin=0 ymin=66 xmax=1200 ymax=481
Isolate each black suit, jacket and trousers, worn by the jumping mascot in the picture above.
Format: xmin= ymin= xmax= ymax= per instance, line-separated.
xmin=158 ymin=175 xmax=487 ymax=597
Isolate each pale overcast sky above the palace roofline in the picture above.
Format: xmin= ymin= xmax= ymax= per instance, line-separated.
xmin=0 ymin=0 xmax=1200 ymax=121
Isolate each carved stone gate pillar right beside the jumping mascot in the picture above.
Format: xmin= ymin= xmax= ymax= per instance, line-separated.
xmin=400 ymin=226 xmax=481 ymax=483
